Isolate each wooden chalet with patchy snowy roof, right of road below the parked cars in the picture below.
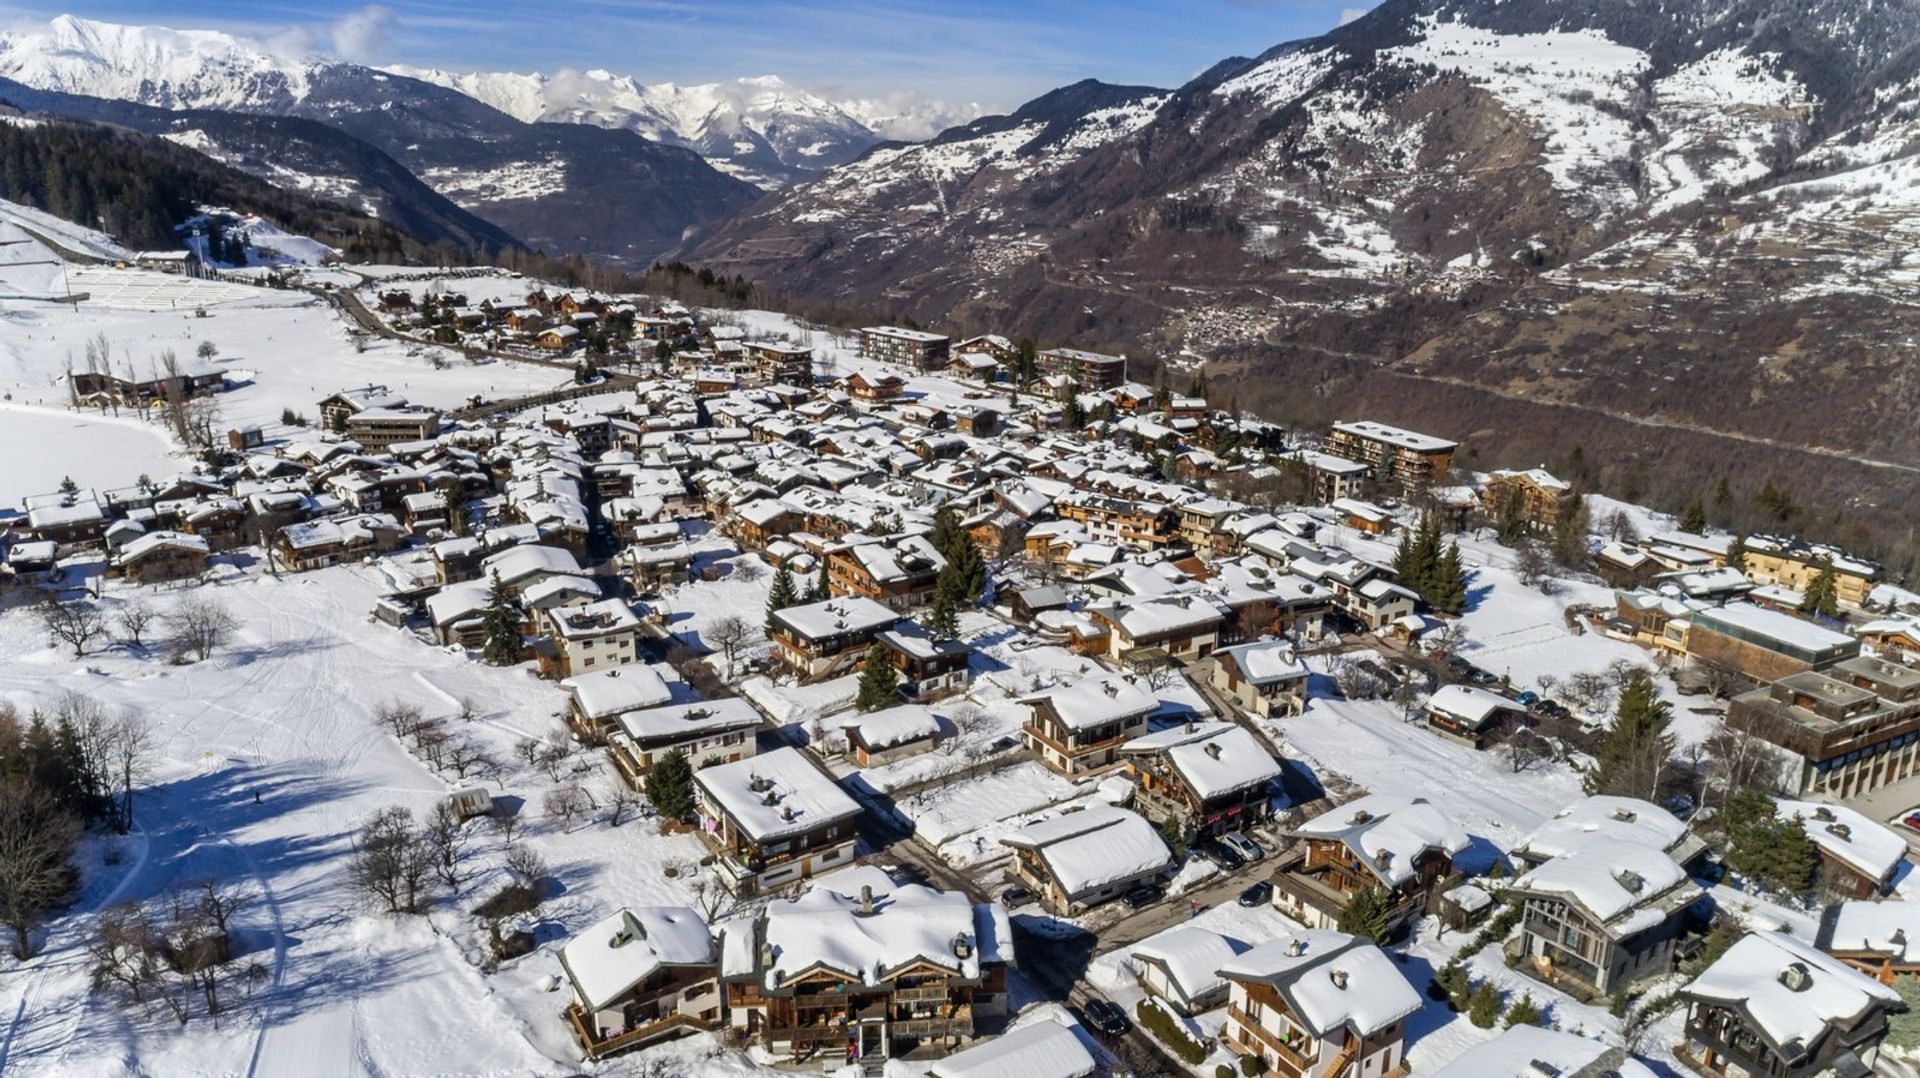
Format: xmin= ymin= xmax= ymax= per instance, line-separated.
xmin=1273 ymin=794 xmax=1471 ymax=932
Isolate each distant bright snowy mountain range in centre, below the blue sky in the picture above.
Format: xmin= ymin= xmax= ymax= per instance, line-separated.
xmin=388 ymin=67 xmax=979 ymax=188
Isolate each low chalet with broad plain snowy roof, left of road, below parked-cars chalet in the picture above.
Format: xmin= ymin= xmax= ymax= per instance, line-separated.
xmin=1000 ymin=805 xmax=1173 ymax=917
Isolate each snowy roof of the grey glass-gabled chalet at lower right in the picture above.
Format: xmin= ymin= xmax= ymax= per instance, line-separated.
xmin=1513 ymin=834 xmax=1699 ymax=926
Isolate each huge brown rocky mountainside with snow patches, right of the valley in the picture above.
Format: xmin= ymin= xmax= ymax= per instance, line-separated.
xmin=691 ymin=0 xmax=1920 ymax=484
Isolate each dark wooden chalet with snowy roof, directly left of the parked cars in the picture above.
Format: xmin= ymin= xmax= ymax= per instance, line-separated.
xmin=1119 ymin=723 xmax=1281 ymax=836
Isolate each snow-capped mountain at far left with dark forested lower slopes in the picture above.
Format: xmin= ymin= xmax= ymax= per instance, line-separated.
xmin=0 ymin=15 xmax=758 ymax=263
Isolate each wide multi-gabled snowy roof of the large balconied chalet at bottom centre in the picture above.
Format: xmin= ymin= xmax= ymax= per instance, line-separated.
xmin=756 ymin=868 xmax=1014 ymax=990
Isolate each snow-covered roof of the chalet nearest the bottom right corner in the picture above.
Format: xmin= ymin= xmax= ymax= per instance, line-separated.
xmin=1680 ymin=932 xmax=1901 ymax=1059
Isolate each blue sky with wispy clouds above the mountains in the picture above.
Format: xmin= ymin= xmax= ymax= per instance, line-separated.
xmin=0 ymin=0 xmax=1375 ymax=110
